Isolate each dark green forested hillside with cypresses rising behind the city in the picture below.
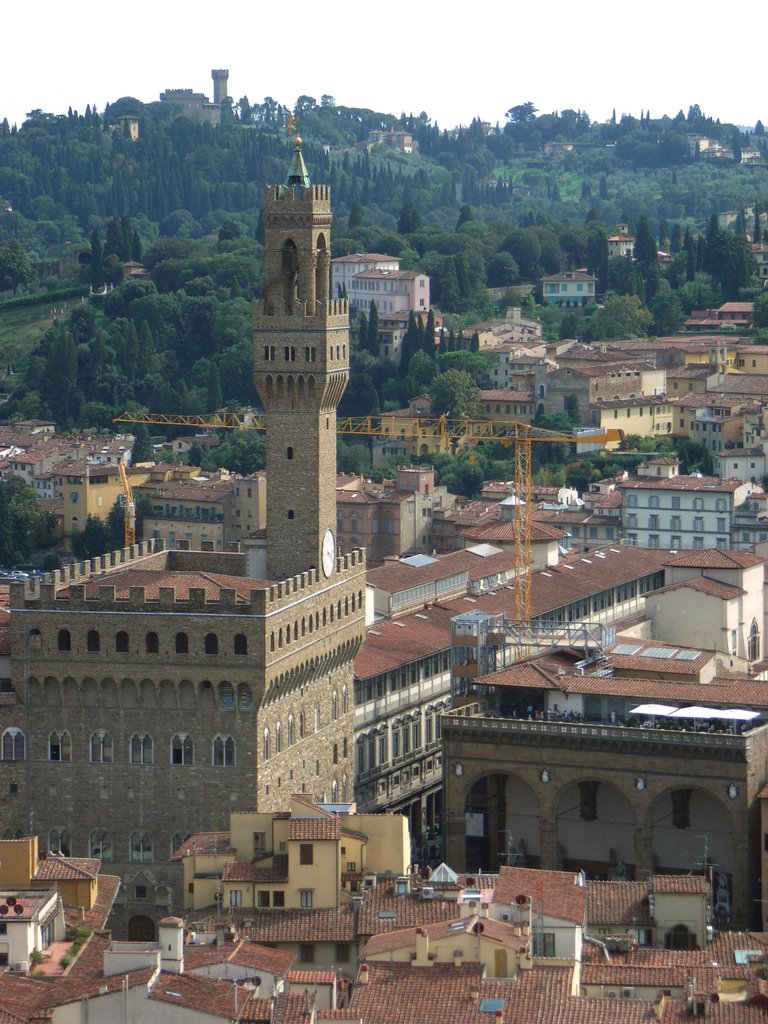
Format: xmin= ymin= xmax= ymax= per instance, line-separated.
xmin=0 ymin=96 xmax=768 ymax=456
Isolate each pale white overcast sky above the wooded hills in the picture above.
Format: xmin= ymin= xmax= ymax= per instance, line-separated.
xmin=0 ymin=0 xmax=768 ymax=128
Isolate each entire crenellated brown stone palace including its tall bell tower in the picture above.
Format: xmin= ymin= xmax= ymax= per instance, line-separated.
xmin=0 ymin=139 xmax=366 ymax=939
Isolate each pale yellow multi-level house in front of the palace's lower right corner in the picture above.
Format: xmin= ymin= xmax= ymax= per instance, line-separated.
xmin=173 ymin=790 xmax=411 ymax=909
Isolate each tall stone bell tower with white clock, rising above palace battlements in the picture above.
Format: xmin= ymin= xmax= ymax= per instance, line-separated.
xmin=253 ymin=136 xmax=349 ymax=580
